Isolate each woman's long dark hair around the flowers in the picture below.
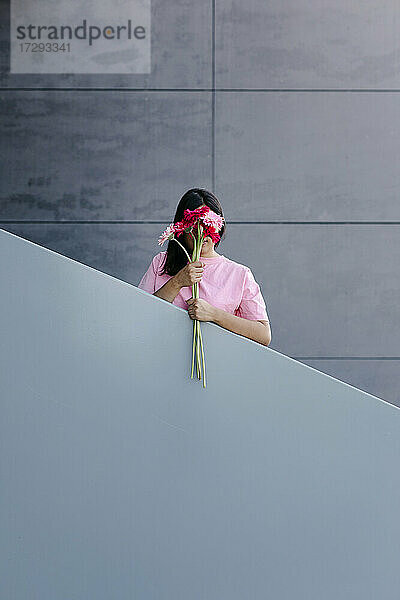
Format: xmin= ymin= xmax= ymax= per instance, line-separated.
xmin=159 ymin=188 xmax=225 ymax=276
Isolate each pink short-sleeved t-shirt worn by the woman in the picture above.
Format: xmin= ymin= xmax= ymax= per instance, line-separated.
xmin=138 ymin=250 xmax=269 ymax=321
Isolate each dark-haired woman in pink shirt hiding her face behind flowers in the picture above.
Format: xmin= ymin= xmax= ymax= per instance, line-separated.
xmin=138 ymin=188 xmax=271 ymax=346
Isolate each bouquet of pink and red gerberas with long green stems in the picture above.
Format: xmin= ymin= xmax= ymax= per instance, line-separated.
xmin=158 ymin=206 xmax=224 ymax=387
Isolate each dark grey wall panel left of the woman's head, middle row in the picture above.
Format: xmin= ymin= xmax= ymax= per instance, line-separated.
xmin=0 ymin=91 xmax=211 ymax=221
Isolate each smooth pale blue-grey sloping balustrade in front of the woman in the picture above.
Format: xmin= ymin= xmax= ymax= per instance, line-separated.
xmin=0 ymin=231 xmax=400 ymax=600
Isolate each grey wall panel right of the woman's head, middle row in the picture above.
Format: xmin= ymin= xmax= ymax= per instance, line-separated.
xmin=216 ymin=92 xmax=400 ymax=221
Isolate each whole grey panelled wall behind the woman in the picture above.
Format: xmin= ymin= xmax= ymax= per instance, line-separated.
xmin=0 ymin=0 xmax=400 ymax=405
